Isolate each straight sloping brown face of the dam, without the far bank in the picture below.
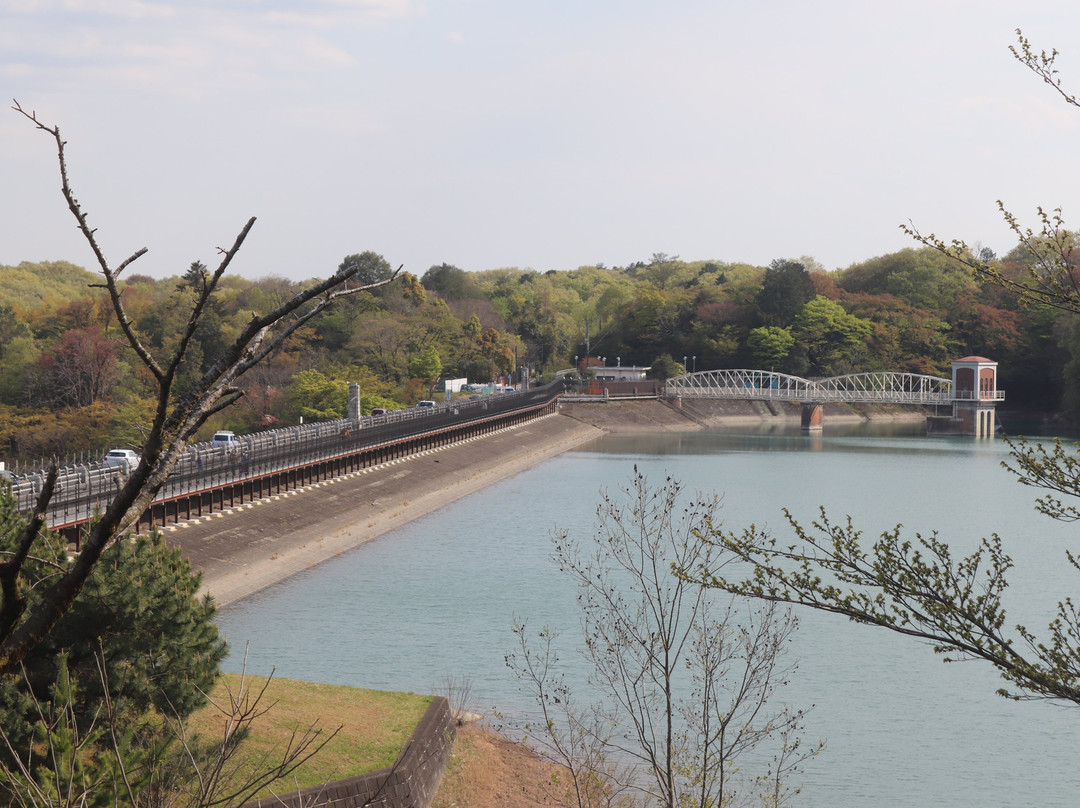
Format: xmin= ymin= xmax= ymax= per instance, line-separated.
xmin=166 ymin=415 xmax=600 ymax=606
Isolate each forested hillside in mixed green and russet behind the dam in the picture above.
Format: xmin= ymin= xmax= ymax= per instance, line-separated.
xmin=0 ymin=241 xmax=1067 ymax=462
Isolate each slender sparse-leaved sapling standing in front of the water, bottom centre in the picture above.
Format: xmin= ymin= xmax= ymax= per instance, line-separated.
xmin=508 ymin=468 xmax=822 ymax=808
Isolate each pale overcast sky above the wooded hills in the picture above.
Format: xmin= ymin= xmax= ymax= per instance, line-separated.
xmin=0 ymin=0 xmax=1080 ymax=279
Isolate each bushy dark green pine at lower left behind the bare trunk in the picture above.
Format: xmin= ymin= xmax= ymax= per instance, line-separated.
xmin=0 ymin=486 xmax=227 ymax=773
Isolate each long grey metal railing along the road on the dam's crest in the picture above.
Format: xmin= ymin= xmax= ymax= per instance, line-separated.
xmin=12 ymin=381 xmax=564 ymax=528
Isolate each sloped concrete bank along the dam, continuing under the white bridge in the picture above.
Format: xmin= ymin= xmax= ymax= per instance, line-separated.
xmin=177 ymin=400 xmax=924 ymax=607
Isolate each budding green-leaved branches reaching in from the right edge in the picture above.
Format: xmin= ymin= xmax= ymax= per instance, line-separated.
xmin=684 ymin=31 xmax=1080 ymax=705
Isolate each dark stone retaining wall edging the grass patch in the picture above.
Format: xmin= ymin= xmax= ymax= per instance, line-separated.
xmin=243 ymin=696 xmax=455 ymax=808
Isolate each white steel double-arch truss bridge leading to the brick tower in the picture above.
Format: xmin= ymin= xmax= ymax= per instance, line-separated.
xmin=665 ymin=369 xmax=959 ymax=404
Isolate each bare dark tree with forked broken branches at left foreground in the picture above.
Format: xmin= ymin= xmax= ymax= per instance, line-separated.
xmin=0 ymin=102 xmax=392 ymax=671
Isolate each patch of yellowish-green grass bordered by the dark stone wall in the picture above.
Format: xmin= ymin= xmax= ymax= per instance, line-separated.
xmin=187 ymin=674 xmax=432 ymax=794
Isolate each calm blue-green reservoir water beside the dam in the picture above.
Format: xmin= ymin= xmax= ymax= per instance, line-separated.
xmin=212 ymin=425 xmax=1080 ymax=808
